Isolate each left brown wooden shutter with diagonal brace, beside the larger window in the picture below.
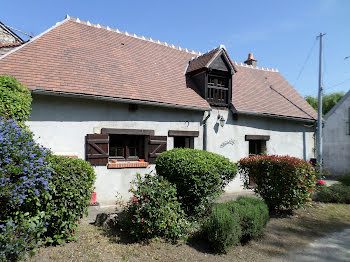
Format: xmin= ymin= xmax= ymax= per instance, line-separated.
xmin=85 ymin=134 xmax=109 ymax=166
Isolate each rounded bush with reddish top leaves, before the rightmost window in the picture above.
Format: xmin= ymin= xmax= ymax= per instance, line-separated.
xmin=238 ymin=155 xmax=317 ymax=211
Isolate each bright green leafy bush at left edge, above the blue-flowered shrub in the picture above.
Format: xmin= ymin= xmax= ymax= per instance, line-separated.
xmin=0 ymin=75 xmax=32 ymax=122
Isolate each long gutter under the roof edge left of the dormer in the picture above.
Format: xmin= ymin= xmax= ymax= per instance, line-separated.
xmin=31 ymin=89 xmax=211 ymax=111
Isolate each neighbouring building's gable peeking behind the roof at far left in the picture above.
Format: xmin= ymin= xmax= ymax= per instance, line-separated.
xmin=0 ymin=22 xmax=24 ymax=57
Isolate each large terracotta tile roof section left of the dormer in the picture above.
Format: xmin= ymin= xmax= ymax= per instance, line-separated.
xmin=0 ymin=16 xmax=210 ymax=108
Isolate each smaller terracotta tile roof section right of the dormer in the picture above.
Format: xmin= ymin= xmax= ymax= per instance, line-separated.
xmin=232 ymin=63 xmax=317 ymax=119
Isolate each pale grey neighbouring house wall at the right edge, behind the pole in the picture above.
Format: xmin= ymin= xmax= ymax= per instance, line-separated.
xmin=323 ymin=90 xmax=350 ymax=175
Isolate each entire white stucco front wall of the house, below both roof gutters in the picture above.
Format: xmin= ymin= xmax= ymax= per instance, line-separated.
xmin=28 ymin=95 xmax=314 ymax=205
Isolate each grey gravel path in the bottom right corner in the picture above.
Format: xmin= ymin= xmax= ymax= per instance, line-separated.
xmin=282 ymin=229 xmax=350 ymax=262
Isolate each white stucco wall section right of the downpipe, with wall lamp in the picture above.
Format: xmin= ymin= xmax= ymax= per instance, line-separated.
xmin=207 ymin=109 xmax=314 ymax=192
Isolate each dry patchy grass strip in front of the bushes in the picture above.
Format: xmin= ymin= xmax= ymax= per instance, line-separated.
xmin=30 ymin=204 xmax=350 ymax=261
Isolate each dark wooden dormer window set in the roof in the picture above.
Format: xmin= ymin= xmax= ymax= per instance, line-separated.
xmin=207 ymin=75 xmax=229 ymax=106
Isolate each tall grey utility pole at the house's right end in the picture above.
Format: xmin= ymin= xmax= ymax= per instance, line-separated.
xmin=317 ymin=33 xmax=325 ymax=175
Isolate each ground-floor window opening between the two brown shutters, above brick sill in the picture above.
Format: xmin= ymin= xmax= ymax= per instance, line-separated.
xmin=109 ymin=135 xmax=145 ymax=161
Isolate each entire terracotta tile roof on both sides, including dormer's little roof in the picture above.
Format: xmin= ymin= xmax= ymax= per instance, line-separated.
xmin=0 ymin=15 xmax=317 ymax=119
